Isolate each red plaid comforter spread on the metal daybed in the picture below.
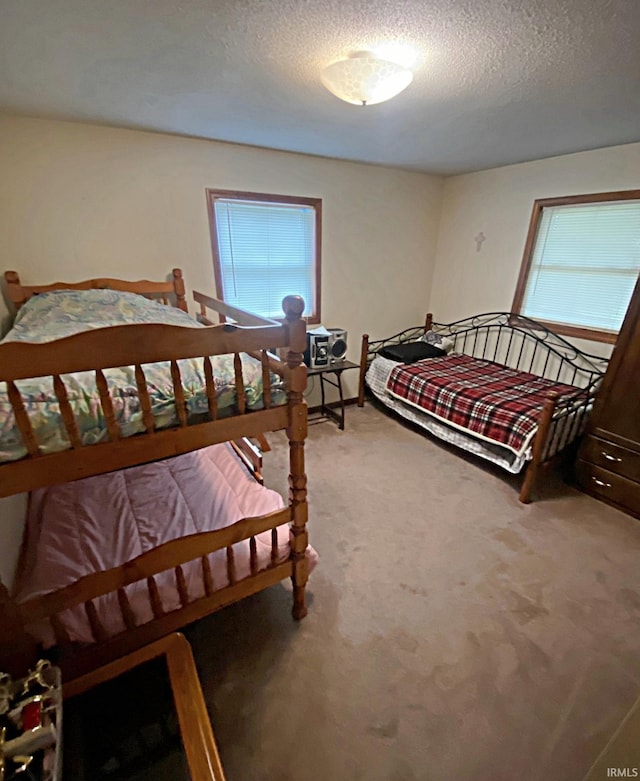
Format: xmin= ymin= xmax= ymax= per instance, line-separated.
xmin=387 ymin=354 xmax=577 ymax=455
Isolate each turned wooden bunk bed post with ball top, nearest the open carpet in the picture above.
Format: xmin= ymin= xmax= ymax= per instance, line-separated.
xmin=282 ymin=296 xmax=309 ymax=621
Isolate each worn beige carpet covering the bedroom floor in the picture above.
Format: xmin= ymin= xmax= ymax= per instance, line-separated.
xmin=188 ymin=405 xmax=640 ymax=781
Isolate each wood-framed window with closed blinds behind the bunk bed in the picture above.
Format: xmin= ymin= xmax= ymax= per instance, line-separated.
xmin=207 ymin=190 xmax=322 ymax=323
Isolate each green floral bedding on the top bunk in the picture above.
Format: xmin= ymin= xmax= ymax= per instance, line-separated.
xmin=0 ymin=290 xmax=286 ymax=462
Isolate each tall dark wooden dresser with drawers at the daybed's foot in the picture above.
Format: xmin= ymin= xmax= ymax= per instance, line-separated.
xmin=577 ymin=278 xmax=640 ymax=518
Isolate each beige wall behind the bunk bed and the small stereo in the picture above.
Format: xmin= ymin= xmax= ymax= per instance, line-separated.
xmin=0 ymin=117 xmax=443 ymax=571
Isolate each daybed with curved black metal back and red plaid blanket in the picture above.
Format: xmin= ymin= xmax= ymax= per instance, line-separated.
xmin=358 ymin=312 xmax=608 ymax=503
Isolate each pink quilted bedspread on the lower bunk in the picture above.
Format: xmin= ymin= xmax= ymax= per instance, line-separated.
xmin=17 ymin=443 xmax=317 ymax=644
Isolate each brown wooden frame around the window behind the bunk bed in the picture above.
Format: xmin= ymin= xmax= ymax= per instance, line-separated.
xmin=205 ymin=188 xmax=322 ymax=325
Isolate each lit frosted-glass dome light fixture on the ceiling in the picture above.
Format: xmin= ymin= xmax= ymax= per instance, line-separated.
xmin=320 ymin=52 xmax=413 ymax=106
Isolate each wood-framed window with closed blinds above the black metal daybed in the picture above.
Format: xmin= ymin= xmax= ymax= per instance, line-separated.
xmin=512 ymin=190 xmax=640 ymax=343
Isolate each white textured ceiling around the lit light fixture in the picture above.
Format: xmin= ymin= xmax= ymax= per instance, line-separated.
xmin=0 ymin=0 xmax=640 ymax=173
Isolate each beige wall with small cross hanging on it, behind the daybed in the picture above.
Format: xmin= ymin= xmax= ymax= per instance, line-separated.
xmin=430 ymin=144 xmax=640 ymax=354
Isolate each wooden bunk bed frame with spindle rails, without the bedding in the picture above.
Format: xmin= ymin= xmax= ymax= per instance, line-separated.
xmin=0 ymin=269 xmax=309 ymax=681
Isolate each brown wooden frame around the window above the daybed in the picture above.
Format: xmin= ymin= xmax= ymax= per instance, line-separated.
xmin=511 ymin=190 xmax=640 ymax=344
